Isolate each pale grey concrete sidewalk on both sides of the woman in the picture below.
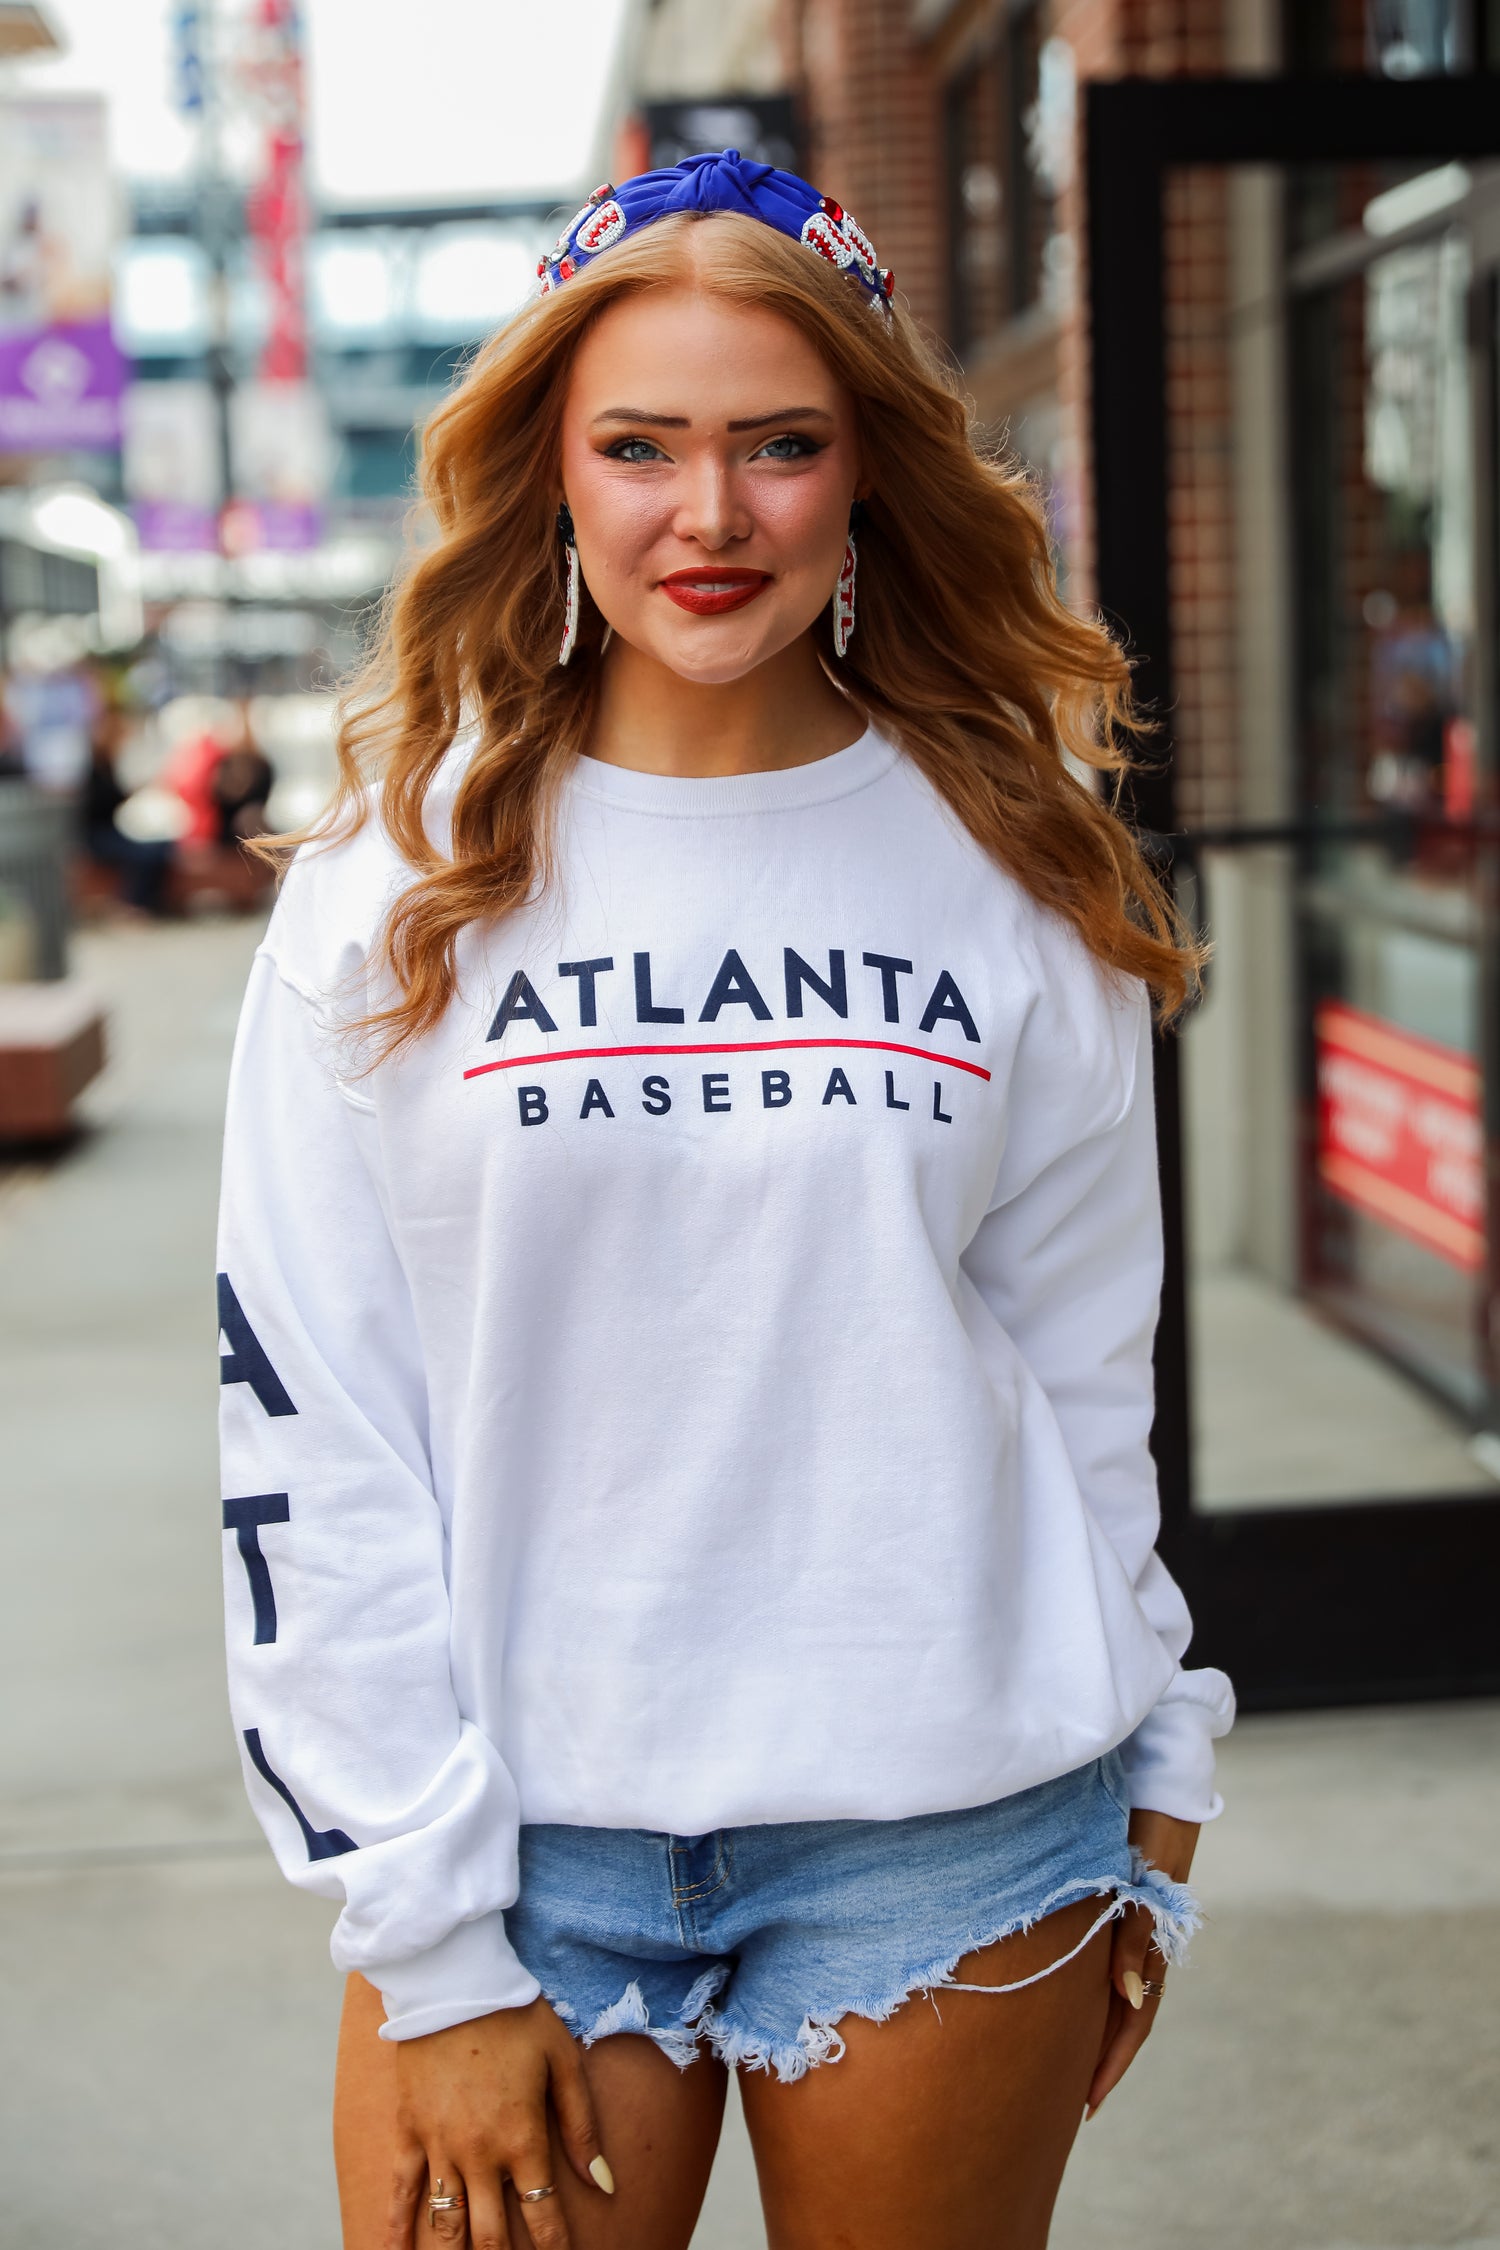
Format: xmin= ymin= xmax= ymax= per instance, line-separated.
xmin=0 ymin=925 xmax=1500 ymax=2250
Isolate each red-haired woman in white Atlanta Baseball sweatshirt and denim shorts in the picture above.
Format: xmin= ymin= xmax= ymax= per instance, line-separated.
xmin=220 ymin=151 xmax=1230 ymax=2250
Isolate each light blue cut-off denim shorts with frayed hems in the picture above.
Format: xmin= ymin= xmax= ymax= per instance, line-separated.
xmin=506 ymin=1751 xmax=1199 ymax=2079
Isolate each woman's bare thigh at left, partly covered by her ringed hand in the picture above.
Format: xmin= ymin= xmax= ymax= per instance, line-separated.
xmin=333 ymin=1976 xmax=729 ymax=2250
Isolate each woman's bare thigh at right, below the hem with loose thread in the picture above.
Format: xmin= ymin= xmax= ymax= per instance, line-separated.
xmin=740 ymin=1899 xmax=1109 ymax=2250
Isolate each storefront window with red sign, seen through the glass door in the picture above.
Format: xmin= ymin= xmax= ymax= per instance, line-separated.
xmin=1289 ymin=145 xmax=1500 ymax=1422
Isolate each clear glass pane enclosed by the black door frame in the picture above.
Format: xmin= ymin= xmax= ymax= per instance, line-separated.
xmin=1167 ymin=167 xmax=1500 ymax=1510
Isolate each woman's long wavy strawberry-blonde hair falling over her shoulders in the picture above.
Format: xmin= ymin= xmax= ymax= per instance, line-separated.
xmin=292 ymin=212 xmax=1199 ymax=1055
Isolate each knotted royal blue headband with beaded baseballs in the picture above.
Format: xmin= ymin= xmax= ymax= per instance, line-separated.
xmin=537 ymin=149 xmax=895 ymax=313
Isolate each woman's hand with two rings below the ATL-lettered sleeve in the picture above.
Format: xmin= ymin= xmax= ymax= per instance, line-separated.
xmin=387 ymin=2000 xmax=614 ymax=2250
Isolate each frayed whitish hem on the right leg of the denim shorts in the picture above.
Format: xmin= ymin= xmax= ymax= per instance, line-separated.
xmin=684 ymin=1847 xmax=1203 ymax=2084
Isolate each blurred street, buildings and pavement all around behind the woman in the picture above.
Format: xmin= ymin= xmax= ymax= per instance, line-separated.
xmin=0 ymin=0 xmax=1500 ymax=2250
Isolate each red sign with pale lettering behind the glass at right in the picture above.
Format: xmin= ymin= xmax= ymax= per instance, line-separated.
xmin=1313 ymin=1001 xmax=1484 ymax=1271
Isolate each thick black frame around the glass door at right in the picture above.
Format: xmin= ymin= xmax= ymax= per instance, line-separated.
xmin=1084 ymin=74 xmax=1500 ymax=1710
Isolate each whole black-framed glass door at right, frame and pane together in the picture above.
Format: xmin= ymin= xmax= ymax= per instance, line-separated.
xmin=1088 ymin=65 xmax=1500 ymax=1703
